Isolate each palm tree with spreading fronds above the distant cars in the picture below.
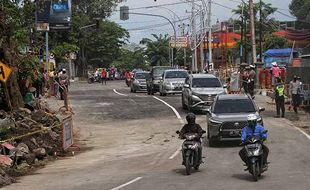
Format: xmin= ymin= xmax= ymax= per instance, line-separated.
xmin=140 ymin=34 xmax=169 ymax=66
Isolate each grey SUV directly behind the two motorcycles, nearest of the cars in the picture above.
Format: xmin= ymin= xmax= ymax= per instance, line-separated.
xmin=207 ymin=94 xmax=265 ymax=146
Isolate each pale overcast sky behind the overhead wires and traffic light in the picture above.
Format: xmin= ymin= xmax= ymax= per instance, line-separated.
xmin=109 ymin=0 xmax=294 ymax=43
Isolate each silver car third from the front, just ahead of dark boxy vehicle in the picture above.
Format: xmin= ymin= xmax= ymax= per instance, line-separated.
xmin=159 ymin=69 xmax=188 ymax=96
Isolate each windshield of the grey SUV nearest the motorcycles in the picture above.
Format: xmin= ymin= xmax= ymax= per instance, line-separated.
xmin=214 ymin=99 xmax=255 ymax=114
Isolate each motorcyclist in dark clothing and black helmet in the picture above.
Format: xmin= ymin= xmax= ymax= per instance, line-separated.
xmin=179 ymin=113 xmax=204 ymax=165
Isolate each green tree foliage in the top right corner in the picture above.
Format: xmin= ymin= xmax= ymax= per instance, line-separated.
xmin=289 ymin=0 xmax=310 ymax=29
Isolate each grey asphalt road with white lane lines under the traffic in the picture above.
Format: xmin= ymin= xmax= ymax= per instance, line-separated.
xmin=4 ymin=81 xmax=310 ymax=190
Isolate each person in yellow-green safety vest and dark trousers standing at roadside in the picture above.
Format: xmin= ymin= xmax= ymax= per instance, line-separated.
xmin=274 ymin=78 xmax=285 ymax=117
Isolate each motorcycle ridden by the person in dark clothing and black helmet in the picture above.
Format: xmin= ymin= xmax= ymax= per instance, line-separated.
xmin=176 ymin=131 xmax=206 ymax=175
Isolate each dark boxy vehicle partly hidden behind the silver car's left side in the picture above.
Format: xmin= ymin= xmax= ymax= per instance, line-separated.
xmin=146 ymin=66 xmax=173 ymax=95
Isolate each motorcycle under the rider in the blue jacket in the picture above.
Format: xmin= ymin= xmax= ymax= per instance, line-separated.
xmin=243 ymin=131 xmax=267 ymax=181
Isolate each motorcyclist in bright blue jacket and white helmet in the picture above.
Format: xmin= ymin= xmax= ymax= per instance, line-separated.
xmin=239 ymin=114 xmax=269 ymax=168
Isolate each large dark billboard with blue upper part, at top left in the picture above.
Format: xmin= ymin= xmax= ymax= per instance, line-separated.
xmin=49 ymin=0 xmax=72 ymax=30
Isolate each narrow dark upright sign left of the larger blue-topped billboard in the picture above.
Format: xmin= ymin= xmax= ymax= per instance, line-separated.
xmin=36 ymin=0 xmax=51 ymax=31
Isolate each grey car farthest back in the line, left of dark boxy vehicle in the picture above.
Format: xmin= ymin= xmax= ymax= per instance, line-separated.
xmin=130 ymin=71 xmax=150 ymax=93
